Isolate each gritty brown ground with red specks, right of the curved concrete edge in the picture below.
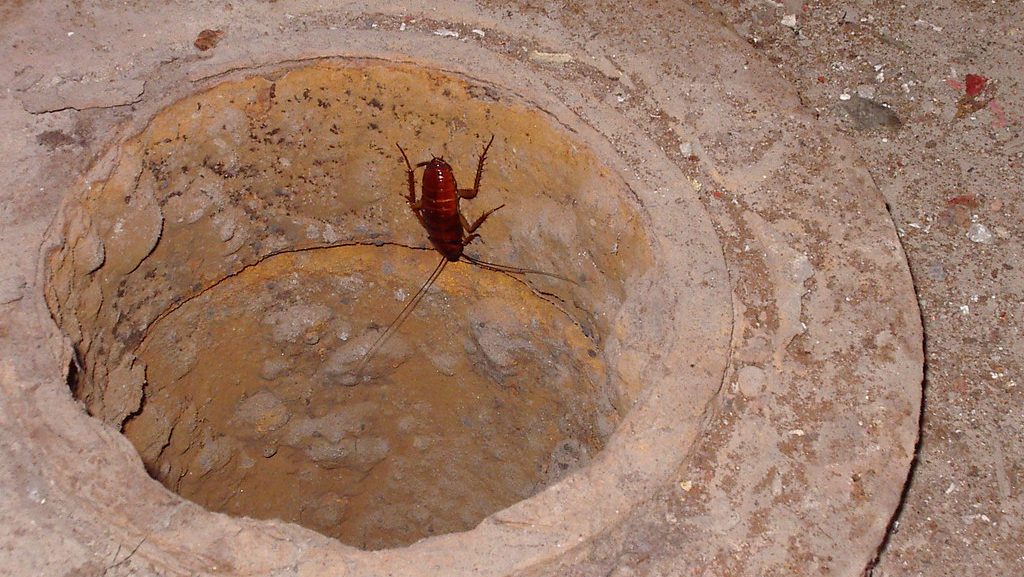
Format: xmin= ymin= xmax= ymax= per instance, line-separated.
xmin=716 ymin=0 xmax=1024 ymax=576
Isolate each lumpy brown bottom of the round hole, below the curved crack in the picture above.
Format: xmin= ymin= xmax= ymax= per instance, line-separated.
xmin=124 ymin=247 xmax=617 ymax=548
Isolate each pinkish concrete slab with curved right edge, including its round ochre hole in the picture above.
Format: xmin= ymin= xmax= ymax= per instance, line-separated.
xmin=0 ymin=2 xmax=923 ymax=575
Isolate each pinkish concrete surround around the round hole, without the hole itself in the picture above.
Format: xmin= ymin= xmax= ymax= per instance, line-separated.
xmin=0 ymin=2 xmax=929 ymax=575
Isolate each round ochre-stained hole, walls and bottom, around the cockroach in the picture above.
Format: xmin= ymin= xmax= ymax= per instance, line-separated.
xmin=47 ymin=66 xmax=650 ymax=548
